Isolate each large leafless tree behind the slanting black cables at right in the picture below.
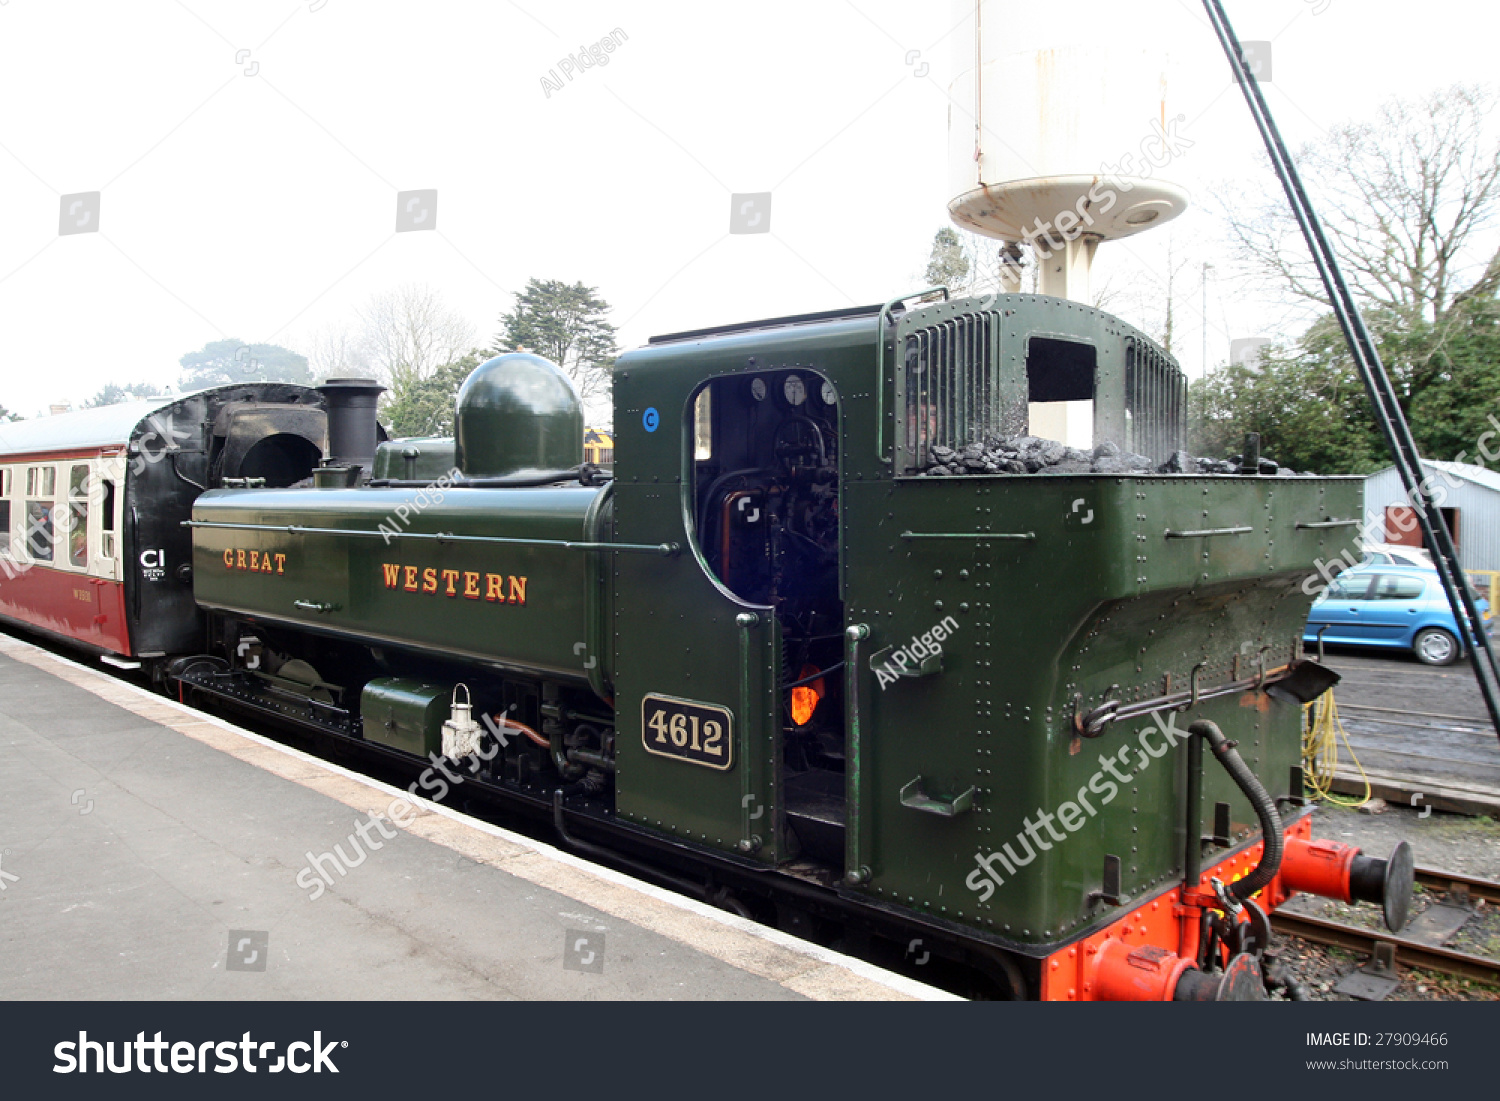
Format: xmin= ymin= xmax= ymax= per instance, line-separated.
xmin=1218 ymin=86 xmax=1500 ymax=329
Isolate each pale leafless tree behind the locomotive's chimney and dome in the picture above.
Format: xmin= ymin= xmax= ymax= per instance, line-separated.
xmin=357 ymin=284 xmax=474 ymax=401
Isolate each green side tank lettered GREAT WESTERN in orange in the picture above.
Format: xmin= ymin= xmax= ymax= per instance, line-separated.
xmin=194 ymin=488 xmax=609 ymax=686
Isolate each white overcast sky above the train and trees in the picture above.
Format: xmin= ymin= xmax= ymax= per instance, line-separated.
xmin=0 ymin=0 xmax=1500 ymax=416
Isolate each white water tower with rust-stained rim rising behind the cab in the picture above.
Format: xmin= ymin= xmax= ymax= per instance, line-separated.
xmin=948 ymin=0 xmax=1191 ymax=444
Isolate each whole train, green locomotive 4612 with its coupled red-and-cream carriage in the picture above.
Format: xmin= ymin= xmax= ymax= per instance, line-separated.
xmin=0 ymin=296 xmax=1412 ymax=1001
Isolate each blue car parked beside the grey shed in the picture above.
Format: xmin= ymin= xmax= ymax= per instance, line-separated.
xmin=1302 ymin=563 xmax=1491 ymax=665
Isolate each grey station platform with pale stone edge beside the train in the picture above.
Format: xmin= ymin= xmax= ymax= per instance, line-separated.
xmin=0 ymin=635 xmax=951 ymax=1002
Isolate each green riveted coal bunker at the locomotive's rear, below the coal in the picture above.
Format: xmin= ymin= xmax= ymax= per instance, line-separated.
xmin=845 ymin=476 xmax=1362 ymax=944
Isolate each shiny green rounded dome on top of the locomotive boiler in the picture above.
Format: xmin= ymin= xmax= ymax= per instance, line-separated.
xmin=455 ymin=353 xmax=584 ymax=479
